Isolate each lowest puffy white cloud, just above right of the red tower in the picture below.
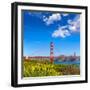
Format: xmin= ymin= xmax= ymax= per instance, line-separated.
xmin=52 ymin=27 xmax=70 ymax=38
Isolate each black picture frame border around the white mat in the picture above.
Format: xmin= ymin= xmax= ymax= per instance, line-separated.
xmin=11 ymin=2 xmax=88 ymax=87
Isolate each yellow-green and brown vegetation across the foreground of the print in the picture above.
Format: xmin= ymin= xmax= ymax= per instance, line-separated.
xmin=23 ymin=60 xmax=80 ymax=77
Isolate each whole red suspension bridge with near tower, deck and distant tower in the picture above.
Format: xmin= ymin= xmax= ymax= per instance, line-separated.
xmin=24 ymin=42 xmax=79 ymax=63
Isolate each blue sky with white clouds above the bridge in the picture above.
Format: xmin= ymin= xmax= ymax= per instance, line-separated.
xmin=22 ymin=11 xmax=80 ymax=56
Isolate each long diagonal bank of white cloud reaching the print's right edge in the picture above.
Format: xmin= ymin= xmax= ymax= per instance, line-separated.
xmin=52 ymin=15 xmax=80 ymax=38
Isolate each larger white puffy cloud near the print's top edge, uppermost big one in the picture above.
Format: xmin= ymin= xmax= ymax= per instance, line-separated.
xmin=43 ymin=13 xmax=61 ymax=25
